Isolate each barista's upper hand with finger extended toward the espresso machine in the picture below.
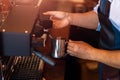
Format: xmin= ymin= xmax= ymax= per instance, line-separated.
xmin=43 ymin=11 xmax=70 ymax=28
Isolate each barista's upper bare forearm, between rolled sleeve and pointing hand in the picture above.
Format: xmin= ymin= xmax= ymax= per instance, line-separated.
xmin=69 ymin=11 xmax=98 ymax=29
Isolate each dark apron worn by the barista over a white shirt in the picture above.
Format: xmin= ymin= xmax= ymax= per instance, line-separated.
xmin=98 ymin=0 xmax=120 ymax=80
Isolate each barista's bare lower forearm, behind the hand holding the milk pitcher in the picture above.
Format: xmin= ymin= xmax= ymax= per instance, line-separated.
xmin=93 ymin=49 xmax=120 ymax=69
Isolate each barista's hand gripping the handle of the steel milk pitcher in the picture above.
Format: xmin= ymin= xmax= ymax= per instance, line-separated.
xmin=67 ymin=41 xmax=95 ymax=60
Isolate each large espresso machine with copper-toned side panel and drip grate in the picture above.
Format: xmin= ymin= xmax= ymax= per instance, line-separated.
xmin=0 ymin=0 xmax=55 ymax=80
